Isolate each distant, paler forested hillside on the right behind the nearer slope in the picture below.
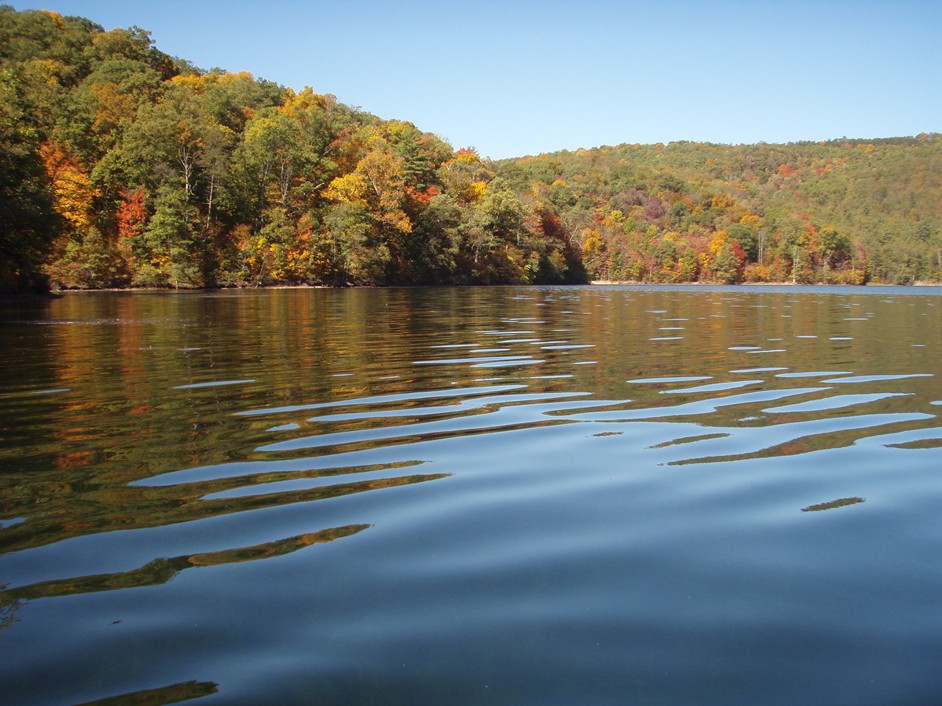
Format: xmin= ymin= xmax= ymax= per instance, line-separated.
xmin=496 ymin=139 xmax=942 ymax=284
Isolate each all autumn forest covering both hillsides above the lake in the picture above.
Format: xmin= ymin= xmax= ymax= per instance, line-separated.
xmin=0 ymin=6 xmax=942 ymax=292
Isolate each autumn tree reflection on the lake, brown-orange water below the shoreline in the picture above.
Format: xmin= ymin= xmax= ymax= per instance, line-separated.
xmin=0 ymin=288 xmax=942 ymax=572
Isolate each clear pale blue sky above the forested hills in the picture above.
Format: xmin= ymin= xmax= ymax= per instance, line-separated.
xmin=6 ymin=0 xmax=942 ymax=159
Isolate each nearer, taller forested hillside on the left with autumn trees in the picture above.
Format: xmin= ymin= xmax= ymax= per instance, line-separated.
xmin=0 ymin=7 xmax=585 ymax=290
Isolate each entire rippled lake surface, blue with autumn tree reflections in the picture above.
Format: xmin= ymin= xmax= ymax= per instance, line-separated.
xmin=0 ymin=287 xmax=942 ymax=705
